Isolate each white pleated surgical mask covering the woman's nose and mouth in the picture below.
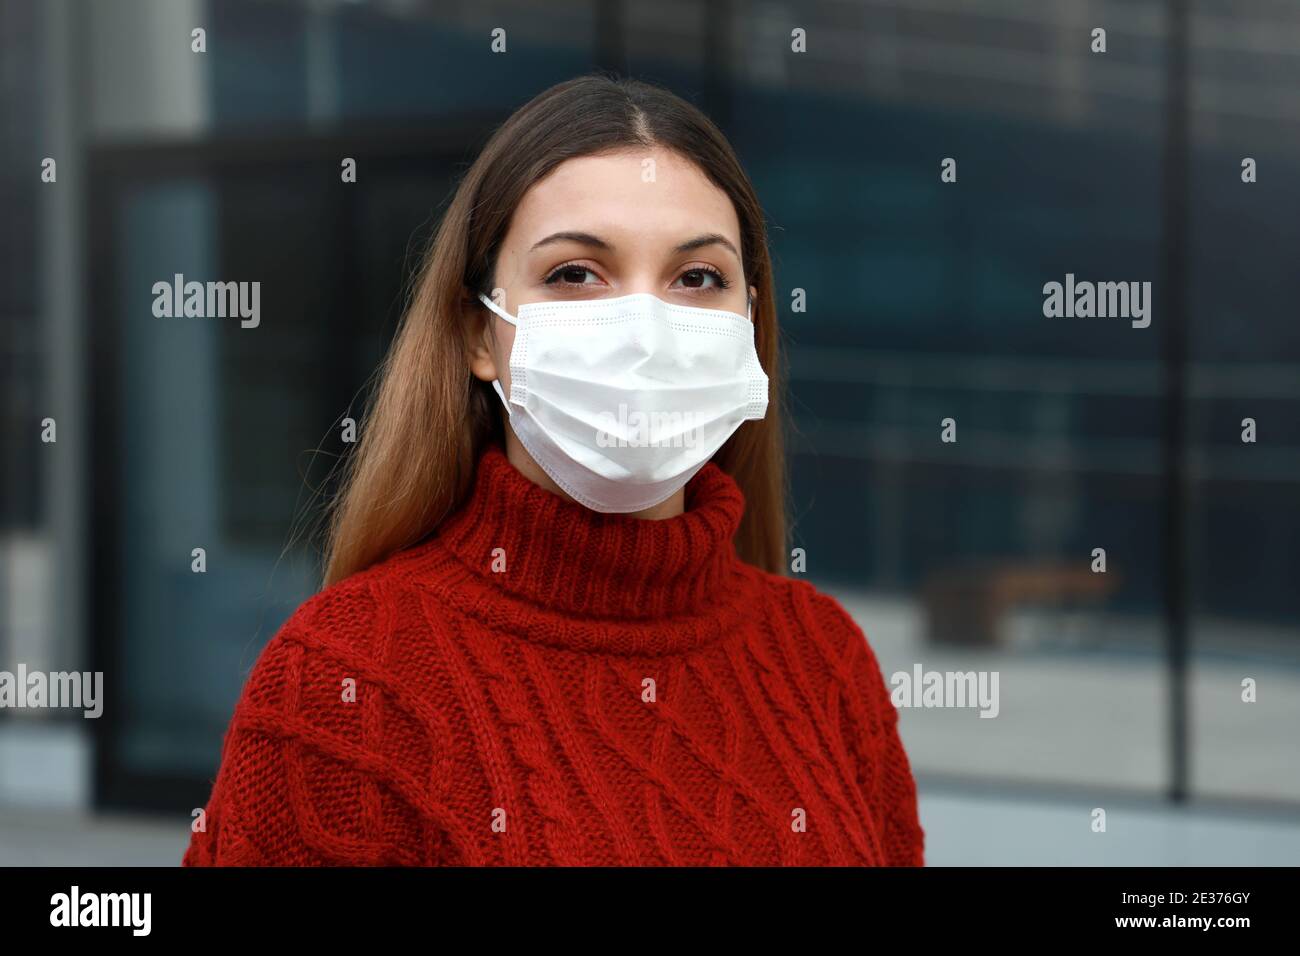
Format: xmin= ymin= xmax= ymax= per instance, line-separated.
xmin=478 ymin=293 xmax=767 ymax=514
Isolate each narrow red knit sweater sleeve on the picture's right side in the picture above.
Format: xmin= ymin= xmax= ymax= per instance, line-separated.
xmin=814 ymin=592 xmax=926 ymax=866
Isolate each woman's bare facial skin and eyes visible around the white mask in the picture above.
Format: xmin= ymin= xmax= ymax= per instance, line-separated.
xmin=471 ymin=148 xmax=754 ymax=516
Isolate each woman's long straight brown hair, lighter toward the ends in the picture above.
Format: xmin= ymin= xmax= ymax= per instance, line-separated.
xmin=324 ymin=75 xmax=787 ymax=587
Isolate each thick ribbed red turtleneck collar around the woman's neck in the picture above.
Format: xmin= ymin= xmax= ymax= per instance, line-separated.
xmin=408 ymin=444 xmax=748 ymax=653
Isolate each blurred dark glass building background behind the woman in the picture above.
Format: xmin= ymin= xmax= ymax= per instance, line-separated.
xmin=0 ymin=0 xmax=1300 ymax=864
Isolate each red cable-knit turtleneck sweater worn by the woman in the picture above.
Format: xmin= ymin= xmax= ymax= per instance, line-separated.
xmin=183 ymin=445 xmax=923 ymax=866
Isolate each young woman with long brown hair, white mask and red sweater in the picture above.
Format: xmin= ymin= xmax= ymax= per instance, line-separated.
xmin=183 ymin=77 xmax=923 ymax=866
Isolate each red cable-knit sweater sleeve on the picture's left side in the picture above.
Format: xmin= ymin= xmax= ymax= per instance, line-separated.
xmin=181 ymin=618 xmax=438 ymax=866
